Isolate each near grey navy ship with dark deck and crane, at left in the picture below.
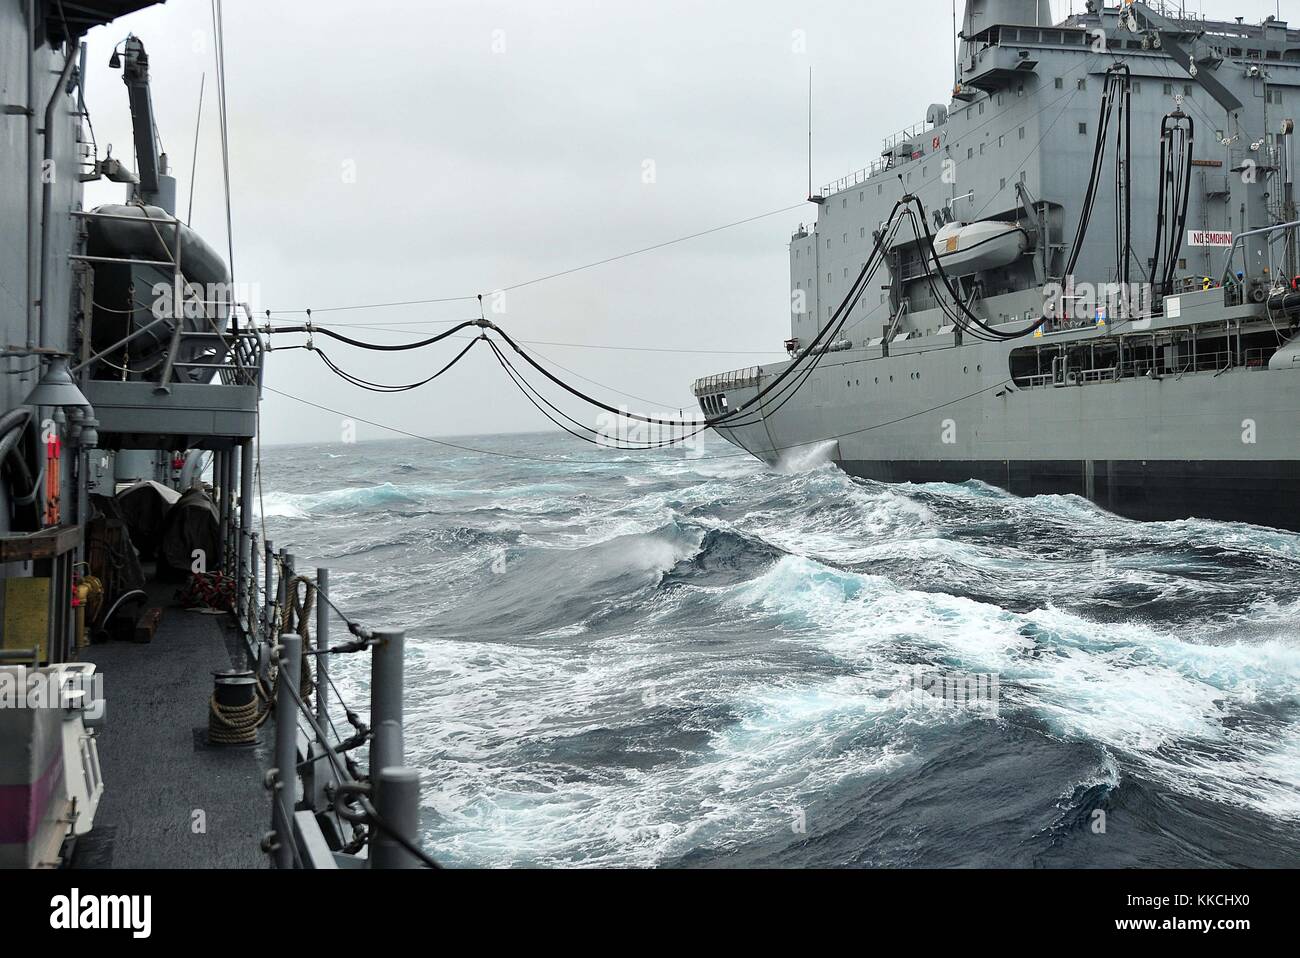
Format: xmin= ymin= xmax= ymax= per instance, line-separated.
xmin=0 ymin=0 xmax=436 ymax=868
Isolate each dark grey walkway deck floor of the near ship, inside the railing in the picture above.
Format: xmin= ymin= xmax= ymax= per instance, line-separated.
xmin=75 ymin=581 xmax=270 ymax=868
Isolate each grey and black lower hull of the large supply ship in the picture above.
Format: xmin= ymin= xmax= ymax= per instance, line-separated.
xmin=718 ymin=330 xmax=1300 ymax=532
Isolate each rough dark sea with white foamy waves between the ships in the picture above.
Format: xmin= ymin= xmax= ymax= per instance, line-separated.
xmin=263 ymin=435 xmax=1300 ymax=867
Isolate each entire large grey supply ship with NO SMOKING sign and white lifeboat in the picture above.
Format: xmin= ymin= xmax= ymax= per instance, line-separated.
xmin=694 ymin=0 xmax=1300 ymax=530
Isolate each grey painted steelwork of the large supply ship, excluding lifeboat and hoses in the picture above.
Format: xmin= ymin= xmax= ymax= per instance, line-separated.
xmin=696 ymin=0 xmax=1300 ymax=529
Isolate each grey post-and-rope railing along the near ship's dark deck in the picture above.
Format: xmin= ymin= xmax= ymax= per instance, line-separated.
xmin=237 ymin=533 xmax=437 ymax=870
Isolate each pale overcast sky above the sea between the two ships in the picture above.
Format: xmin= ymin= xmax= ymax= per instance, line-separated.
xmin=87 ymin=0 xmax=1296 ymax=443
